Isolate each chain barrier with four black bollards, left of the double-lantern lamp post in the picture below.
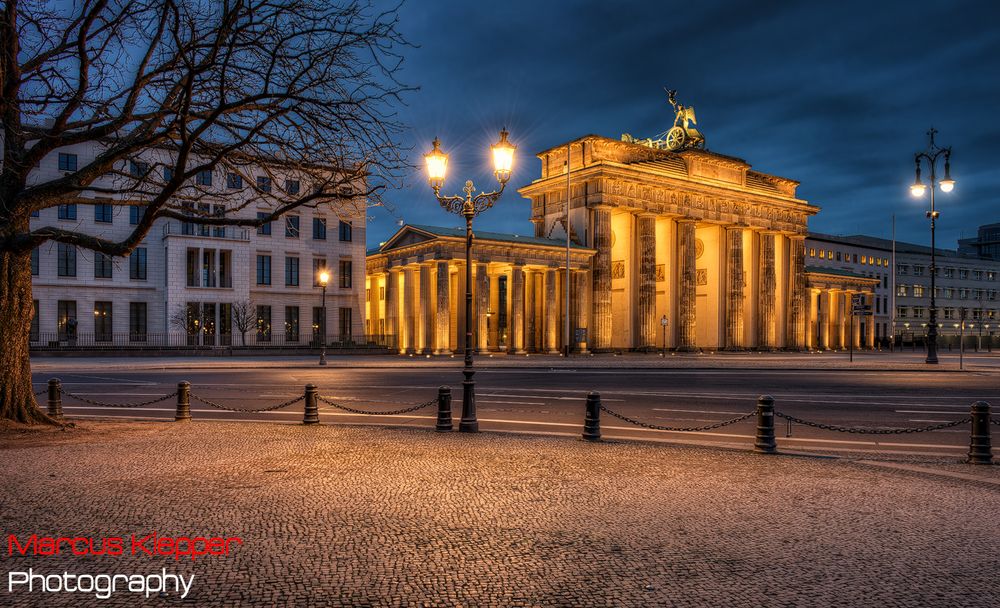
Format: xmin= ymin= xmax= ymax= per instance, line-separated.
xmin=42 ymin=378 xmax=452 ymax=431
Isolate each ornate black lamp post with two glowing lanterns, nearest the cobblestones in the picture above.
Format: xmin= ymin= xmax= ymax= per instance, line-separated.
xmin=424 ymin=129 xmax=516 ymax=433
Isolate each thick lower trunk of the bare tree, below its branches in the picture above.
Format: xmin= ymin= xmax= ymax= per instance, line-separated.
xmin=0 ymin=251 xmax=55 ymax=424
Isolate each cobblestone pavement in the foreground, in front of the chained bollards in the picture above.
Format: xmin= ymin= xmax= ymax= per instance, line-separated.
xmin=0 ymin=422 xmax=1000 ymax=607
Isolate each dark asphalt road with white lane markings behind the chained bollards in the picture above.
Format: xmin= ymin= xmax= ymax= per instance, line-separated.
xmin=34 ymin=368 xmax=1000 ymax=455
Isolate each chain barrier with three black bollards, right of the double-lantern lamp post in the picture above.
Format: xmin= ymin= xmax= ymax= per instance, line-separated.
xmin=582 ymin=392 xmax=1000 ymax=464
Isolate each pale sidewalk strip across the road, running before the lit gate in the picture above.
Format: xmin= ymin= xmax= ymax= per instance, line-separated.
xmin=31 ymin=351 xmax=1000 ymax=373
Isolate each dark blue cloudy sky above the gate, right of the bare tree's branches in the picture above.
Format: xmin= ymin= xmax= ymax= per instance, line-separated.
xmin=368 ymin=0 xmax=1000 ymax=248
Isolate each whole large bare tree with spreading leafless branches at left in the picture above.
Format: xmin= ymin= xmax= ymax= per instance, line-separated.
xmin=0 ymin=0 xmax=407 ymax=422
